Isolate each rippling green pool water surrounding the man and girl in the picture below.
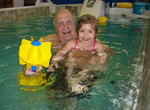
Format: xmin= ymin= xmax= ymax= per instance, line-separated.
xmin=0 ymin=14 xmax=148 ymax=110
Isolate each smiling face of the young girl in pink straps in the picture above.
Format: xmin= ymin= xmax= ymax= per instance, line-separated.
xmin=78 ymin=24 xmax=96 ymax=44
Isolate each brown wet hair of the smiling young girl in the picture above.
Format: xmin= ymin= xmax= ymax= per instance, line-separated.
xmin=77 ymin=14 xmax=98 ymax=37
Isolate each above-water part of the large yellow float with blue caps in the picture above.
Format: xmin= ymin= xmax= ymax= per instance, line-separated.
xmin=19 ymin=36 xmax=52 ymax=71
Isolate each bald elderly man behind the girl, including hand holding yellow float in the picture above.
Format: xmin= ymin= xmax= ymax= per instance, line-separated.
xmin=23 ymin=9 xmax=77 ymax=75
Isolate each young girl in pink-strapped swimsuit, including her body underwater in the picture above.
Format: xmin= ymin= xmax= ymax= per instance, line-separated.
xmin=47 ymin=14 xmax=108 ymax=94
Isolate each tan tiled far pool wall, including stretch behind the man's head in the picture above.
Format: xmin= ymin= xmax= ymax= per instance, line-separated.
xmin=0 ymin=4 xmax=81 ymax=20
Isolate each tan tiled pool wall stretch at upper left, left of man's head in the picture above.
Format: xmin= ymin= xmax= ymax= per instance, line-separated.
xmin=0 ymin=6 xmax=50 ymax=20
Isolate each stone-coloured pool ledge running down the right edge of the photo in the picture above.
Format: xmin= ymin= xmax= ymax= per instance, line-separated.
xmin=136 ymin=20 xmax=150 ymax=110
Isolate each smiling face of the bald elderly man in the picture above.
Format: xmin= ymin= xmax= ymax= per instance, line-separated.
xmin=54 ymin=11 xmax=76 ymax=43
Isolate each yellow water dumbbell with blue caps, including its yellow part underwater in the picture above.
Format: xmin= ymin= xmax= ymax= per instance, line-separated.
xmin=17 ymin=36 xmax=54 ymax=92
